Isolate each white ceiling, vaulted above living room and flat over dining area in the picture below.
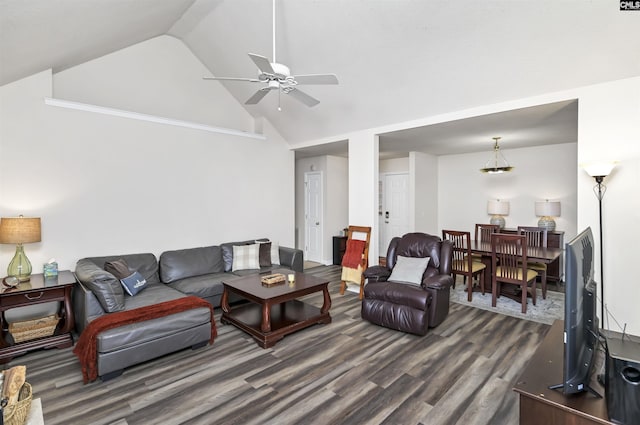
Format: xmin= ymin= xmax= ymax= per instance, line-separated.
xmin=0 ymin=0 xmax=640 ymax=154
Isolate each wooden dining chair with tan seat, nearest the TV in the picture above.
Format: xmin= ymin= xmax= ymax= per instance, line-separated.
xmin=491 ymin=233 xmax=538 ymax=314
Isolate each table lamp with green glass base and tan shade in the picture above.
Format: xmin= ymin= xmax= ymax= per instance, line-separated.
xmin=0 ymin=216 xmax=40 ymax=282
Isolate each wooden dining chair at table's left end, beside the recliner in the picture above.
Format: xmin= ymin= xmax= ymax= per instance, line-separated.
xmin=442 ymin=230 xmax=487 ymax=302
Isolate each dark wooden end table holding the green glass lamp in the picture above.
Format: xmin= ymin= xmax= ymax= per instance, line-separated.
xmin=0 ymin=270 xmax=76 ymax=364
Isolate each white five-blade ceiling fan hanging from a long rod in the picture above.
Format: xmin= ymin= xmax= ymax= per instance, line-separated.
xmin=203 ymin=0 xmax=338 ymax=111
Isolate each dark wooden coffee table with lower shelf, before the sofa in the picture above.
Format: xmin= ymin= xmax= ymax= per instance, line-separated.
xmin=220 ymin=270 xmax=331 ymax=348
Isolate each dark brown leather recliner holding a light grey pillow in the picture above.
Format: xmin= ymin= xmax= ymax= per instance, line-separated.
xmin=361 ymin=233 xmax=453 ymax=335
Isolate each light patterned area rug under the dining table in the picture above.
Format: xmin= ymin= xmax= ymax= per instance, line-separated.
xmin=451 ymin=281 xmax=564 ymax=325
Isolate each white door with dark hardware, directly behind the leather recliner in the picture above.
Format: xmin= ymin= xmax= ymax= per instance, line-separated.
xmin=380 ymin=173 xmax=409 ymax=252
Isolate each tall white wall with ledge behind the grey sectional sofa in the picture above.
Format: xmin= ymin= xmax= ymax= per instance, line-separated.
xmin=0 ymin=37 xmax=294 ymax=272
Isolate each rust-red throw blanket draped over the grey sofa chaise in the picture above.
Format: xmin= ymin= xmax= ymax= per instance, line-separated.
xmin=73 ymin=296 xmax=218 ymax=384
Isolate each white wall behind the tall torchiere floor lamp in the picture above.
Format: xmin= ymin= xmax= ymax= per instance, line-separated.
xmin=577 ymin=77 xmax=640 ymax=335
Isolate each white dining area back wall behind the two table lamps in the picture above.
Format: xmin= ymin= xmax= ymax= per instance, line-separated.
xmin=438 ymin=143 xmax=577 ymax=240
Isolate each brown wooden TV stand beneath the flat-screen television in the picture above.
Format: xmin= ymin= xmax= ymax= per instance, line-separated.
xmin=514 ymin=320 xmax=611 ymax=425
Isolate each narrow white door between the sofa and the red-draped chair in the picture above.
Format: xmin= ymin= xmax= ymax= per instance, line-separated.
xmin=304 ymin=171 xmax=324 ymax=262
